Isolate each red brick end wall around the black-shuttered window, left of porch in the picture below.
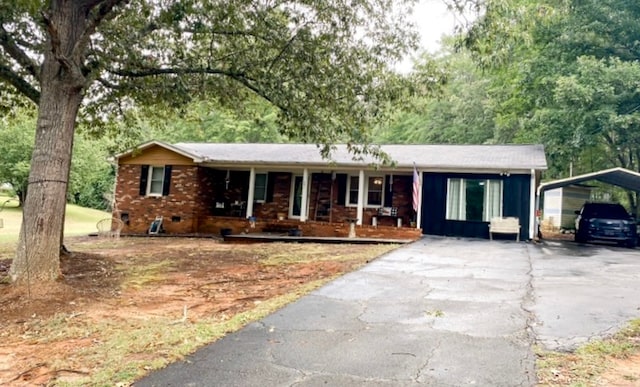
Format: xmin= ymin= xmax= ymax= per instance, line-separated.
xmin=114 ymin=165 xmax=201 ymax=234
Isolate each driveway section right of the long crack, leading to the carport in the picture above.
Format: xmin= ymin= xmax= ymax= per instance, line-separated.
xmin=529 ymin=241 xmax=640 ymax=350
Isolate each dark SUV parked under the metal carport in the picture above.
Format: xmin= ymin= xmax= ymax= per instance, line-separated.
xmin=575 ymin=202 xmax=638 ymax=248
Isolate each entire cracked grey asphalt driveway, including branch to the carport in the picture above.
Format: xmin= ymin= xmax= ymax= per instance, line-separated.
xmin=136 ymin=236 xmax=640 ymax=387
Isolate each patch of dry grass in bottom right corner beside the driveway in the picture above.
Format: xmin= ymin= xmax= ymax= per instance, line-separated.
xmin=536 ymin=319 xmax=640 ymax=386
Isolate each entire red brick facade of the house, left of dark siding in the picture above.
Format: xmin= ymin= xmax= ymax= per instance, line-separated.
xmin=114 ymin=164 xmax=421 ymax=239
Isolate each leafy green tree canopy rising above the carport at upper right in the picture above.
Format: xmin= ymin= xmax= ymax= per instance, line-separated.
xmin=464 ymin=0 xmax=640 ymax=175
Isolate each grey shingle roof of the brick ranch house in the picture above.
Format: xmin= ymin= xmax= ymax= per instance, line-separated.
xmin=173 ymin=143 xmax=547 ymax=170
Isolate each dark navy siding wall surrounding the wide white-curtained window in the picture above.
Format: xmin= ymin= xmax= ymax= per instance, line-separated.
xmin=422 ymin=173 xmax=531 ymax=239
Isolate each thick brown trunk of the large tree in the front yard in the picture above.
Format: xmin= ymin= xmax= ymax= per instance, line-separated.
xmin=11 ymin=0 xmax=86 ymax=284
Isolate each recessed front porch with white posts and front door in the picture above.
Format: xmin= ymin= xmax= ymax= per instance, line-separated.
xmin=199 ymin=168 xmax=416 ymax=229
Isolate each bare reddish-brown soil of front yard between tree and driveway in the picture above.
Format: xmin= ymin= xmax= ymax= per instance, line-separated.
xmin=0 ymin=237 xmax=393 ymax=386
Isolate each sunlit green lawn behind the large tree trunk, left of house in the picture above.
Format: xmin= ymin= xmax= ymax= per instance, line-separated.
xmin=0 ymin=196 xmax=111 ymax=243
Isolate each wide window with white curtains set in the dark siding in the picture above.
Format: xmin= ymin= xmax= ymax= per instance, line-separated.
xmin=446 ymin=179 xmax=502 ymax=222
